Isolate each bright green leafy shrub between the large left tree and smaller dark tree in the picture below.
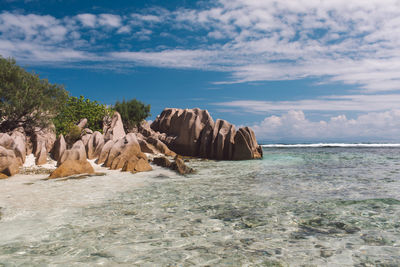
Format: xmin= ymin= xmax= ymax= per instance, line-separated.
xmin=53 ymin=96 xmax=111 ymax=135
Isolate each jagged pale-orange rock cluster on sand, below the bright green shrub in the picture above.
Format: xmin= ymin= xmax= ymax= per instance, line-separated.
xmin=50 ymin=112 xmax=152 ymax=178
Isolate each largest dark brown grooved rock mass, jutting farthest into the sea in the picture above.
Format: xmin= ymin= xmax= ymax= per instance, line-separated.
xmin=150 ymin=108 xmax=262 ymax=160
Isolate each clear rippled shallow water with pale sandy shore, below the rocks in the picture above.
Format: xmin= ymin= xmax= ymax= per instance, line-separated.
xmin=0 ymin=147 xmax=400 ymax=266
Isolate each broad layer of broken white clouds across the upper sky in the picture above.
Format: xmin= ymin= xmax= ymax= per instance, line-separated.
xmin=0 ymin=0 xmax=400 ymax=93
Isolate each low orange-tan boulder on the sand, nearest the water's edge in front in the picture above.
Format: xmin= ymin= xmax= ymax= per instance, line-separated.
xmin=49 ymin=159 xmax=94 ymax=178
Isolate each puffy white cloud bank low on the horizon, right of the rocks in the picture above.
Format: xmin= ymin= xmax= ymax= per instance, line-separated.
xmin=252 ymin=109 xmax=400 ymax=142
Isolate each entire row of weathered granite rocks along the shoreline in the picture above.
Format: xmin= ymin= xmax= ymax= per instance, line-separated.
xmin=0 ymin=109 xmax=262 ymax=178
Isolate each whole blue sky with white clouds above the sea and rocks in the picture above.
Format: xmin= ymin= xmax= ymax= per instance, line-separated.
xmin=0 ymin=0 xmax=400 ymax=143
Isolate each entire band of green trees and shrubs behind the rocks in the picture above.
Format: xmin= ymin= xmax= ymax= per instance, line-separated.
xmin=0 ymin=56 xmax=150 ymax=136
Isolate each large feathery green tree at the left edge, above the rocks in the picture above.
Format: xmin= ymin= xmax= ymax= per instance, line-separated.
xmin=0 ymin=56 xmax=68 ymax=132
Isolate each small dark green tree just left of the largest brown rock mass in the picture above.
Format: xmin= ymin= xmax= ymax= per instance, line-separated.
xmin=114 ymin=99 xmax=150 ymax=131
